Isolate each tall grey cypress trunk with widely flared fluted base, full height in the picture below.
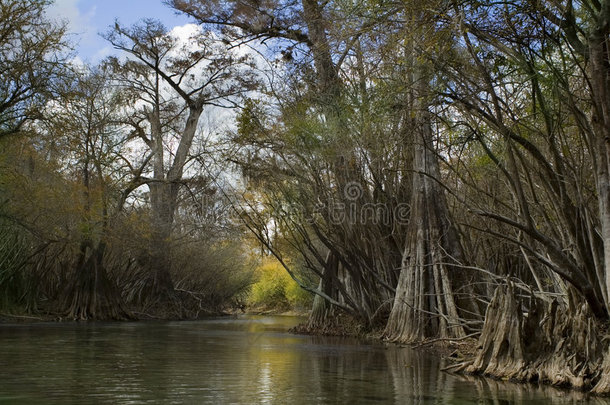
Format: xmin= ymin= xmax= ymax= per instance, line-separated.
xmin=384 ymin=7 xmax=478 ymax=342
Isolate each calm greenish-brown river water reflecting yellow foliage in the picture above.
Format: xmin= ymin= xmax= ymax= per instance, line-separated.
xmin=0 ymin=316 xmax=610 ymax=405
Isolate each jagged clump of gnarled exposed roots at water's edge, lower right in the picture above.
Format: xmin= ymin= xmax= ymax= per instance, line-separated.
xmin=454 ymin=283 xmax=610 ymax=394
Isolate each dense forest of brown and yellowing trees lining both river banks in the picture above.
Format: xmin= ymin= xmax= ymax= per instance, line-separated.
xmin=0 ymin=0 xmax=610 ymax=394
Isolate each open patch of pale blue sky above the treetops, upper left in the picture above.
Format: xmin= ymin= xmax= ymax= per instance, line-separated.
xmin=48 ymin=0 xmax=192 ymax=63
